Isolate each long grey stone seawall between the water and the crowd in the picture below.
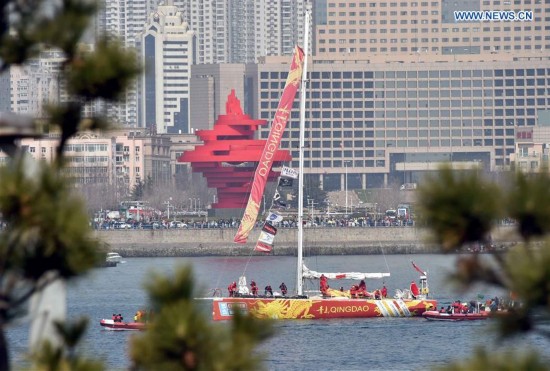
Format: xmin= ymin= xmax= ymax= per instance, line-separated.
xmin=95 ymin=226 xmax=520 ymax=257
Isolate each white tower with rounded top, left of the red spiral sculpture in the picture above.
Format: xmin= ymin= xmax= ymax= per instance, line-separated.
xmin=140 ymin=1 xmax=195 ymax=134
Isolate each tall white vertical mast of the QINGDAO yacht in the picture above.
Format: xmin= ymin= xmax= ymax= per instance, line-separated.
xmin=296 ymin=10 xmax=311 ymax=295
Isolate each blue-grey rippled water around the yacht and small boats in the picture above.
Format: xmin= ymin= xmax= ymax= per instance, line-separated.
xmin=8 ymin=255 xmax=548 ymax=370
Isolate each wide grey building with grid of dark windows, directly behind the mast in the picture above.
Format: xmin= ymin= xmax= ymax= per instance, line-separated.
xmin=253 ymin=55 xmax=550 ymax=190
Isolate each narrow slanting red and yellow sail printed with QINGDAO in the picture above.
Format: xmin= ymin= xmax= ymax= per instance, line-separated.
xmin=233 ymin=46 xmax=304 ymax=243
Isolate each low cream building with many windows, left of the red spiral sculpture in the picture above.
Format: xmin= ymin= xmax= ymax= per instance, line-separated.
xmin=0 ymin=129 xmax=179 ymax=198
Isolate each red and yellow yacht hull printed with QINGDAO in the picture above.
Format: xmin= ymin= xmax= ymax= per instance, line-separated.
xmin=212 ymin=297 xmax=437 ymax=321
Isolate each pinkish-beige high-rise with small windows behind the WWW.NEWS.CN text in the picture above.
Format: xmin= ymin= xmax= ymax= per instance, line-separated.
xmin=313 ymin=0 xmax=550 ymax=57
